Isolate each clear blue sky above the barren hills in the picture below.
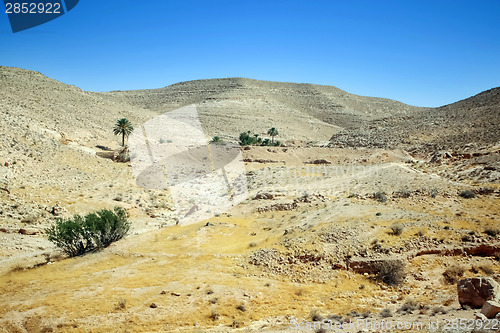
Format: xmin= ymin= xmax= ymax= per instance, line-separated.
xmin=0 ymin=0 xmax=500 ymax=106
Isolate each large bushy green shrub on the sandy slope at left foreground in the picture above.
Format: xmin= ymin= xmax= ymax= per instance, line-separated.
xmin=45 ymin=207 xmax=130 ymax=257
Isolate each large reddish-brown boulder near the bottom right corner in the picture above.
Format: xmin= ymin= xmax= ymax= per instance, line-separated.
xmin=457 ymin=277 xmax=500 ymax=309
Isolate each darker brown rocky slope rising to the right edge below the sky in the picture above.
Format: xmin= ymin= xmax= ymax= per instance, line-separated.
xmin=331 ymin=88 xmax=500 ymax=152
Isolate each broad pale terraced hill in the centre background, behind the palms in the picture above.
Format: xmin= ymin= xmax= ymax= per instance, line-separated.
xmin=102 ymin=78 xmax=421 ymax=141
